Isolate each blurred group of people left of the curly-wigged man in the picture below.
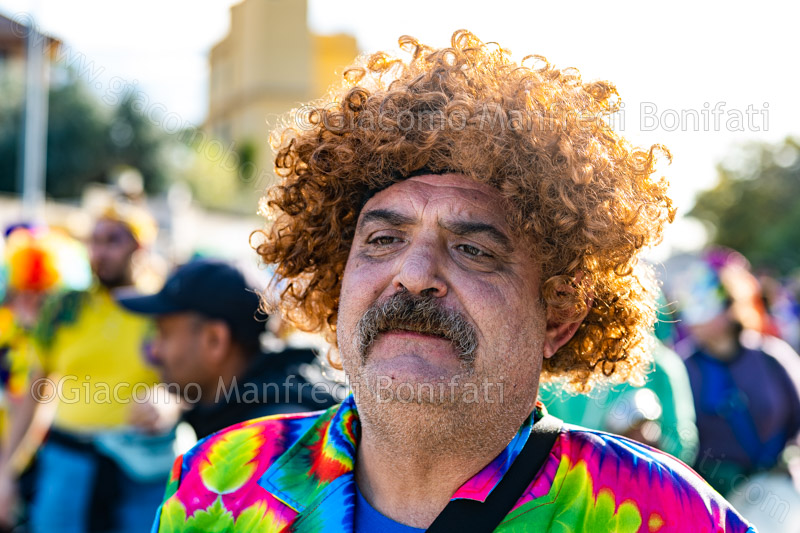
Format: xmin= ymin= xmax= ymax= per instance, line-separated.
xmin=0 ymin=198 xmax=336 ymax=533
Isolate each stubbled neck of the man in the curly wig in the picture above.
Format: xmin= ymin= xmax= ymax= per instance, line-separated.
xmin=355 ymin=402 xmax=521 ymax=528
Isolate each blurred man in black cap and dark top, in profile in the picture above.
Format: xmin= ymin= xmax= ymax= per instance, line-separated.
xmin=119 ymin=260 xmax=333 ymax=438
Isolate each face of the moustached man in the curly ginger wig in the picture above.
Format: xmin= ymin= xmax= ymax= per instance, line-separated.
xmin=337 ymin=174 xmax=564 ymax=434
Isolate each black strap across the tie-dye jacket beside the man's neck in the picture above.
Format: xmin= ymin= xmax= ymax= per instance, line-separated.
xmin=427 ymin=415 xmax=563 ymax=533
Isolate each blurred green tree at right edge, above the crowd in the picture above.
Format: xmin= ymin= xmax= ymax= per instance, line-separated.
xmin=688 ymin=138 xmax=800 ymax=274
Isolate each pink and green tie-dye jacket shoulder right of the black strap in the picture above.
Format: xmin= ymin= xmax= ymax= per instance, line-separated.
xmin=496 ymin=424 xmax=754 ymax=533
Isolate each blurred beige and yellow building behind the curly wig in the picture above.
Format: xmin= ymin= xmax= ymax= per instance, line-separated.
xmin=205 ymin=0 xmax=358 ymax=181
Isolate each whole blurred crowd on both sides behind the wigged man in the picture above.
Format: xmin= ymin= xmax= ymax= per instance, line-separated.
xmin=0 ymin=195 xmax=800 ymax=532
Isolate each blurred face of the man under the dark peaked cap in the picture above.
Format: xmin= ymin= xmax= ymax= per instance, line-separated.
xmin=153 ymin=313 xmax=207 ymax=392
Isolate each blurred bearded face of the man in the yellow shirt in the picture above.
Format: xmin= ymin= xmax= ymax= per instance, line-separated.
xmin=89 ymin=219 xmax=139 ymax=288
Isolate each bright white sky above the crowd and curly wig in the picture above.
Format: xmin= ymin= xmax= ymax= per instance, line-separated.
xmin=0 ymin=0 xmax=800 ymax=258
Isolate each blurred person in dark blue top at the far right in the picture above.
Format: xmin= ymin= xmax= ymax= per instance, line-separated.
xmin=676 ymin=249 xmax=800 ymax=494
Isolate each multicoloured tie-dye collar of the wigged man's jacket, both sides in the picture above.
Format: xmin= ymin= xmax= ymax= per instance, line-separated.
xmin=261 ymin=394 xmax=545 ymax=513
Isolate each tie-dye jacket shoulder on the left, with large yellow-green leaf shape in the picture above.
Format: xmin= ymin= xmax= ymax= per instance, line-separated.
xmin=153 ymin=408 xmax=335 ymax=533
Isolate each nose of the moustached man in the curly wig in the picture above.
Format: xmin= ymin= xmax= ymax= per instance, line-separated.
xmin=392 ymin=241 xmax=447 ymax=298
